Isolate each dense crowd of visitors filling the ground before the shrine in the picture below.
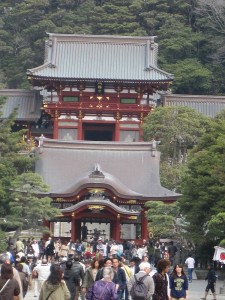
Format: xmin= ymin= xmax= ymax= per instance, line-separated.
xmin=0 ymin=237 xmax=216 ymax=300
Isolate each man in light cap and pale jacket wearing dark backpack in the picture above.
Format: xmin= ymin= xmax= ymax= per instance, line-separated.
xmin=127 ymin=262 xmax=154 ymax=300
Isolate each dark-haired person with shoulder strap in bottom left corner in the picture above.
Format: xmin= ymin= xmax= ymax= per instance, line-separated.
xmin=0 ymin=263 xmax=20 ymax=300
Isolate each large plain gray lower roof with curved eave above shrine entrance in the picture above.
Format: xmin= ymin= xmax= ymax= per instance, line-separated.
xmin=36 ymin=139 xmax=180 ymax=200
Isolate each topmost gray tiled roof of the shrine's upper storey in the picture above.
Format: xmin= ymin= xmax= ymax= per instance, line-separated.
xmin=28 ymin=34 xmax=173 ymax=82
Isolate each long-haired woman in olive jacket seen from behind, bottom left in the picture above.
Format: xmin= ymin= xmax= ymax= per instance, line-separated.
xmin=39 ymin=264 xmax=71 ymax=300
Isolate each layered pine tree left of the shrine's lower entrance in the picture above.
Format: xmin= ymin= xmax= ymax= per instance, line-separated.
xmin=6 ymin=173 xmax=60 ymax=236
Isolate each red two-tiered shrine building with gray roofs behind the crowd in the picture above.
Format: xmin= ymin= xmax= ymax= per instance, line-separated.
xmin=27 ymin=33 xmax=179 ymax=241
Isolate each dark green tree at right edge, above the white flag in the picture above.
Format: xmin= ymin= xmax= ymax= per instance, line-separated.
xmin=179 ymin=118 xmax=225 ymax=244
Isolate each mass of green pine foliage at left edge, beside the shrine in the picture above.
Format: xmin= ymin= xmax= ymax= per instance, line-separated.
xmin=0 ymin=98 xmax=58 ymax=238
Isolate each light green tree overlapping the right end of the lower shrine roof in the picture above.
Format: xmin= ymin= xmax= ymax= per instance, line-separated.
xmin=143 ymin=106 xmax=211 ymax=191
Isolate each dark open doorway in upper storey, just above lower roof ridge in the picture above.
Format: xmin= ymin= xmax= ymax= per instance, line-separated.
xmin=83 ymin=123 xmax=115 ymax=141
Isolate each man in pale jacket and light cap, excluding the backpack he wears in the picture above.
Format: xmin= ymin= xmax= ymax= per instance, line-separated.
xmin=127 ymin=262 xmax=154 ymax=300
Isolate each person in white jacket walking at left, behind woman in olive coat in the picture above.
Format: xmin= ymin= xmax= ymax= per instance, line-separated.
xmin=32 ymin=258 xmax=50 ymax=297
